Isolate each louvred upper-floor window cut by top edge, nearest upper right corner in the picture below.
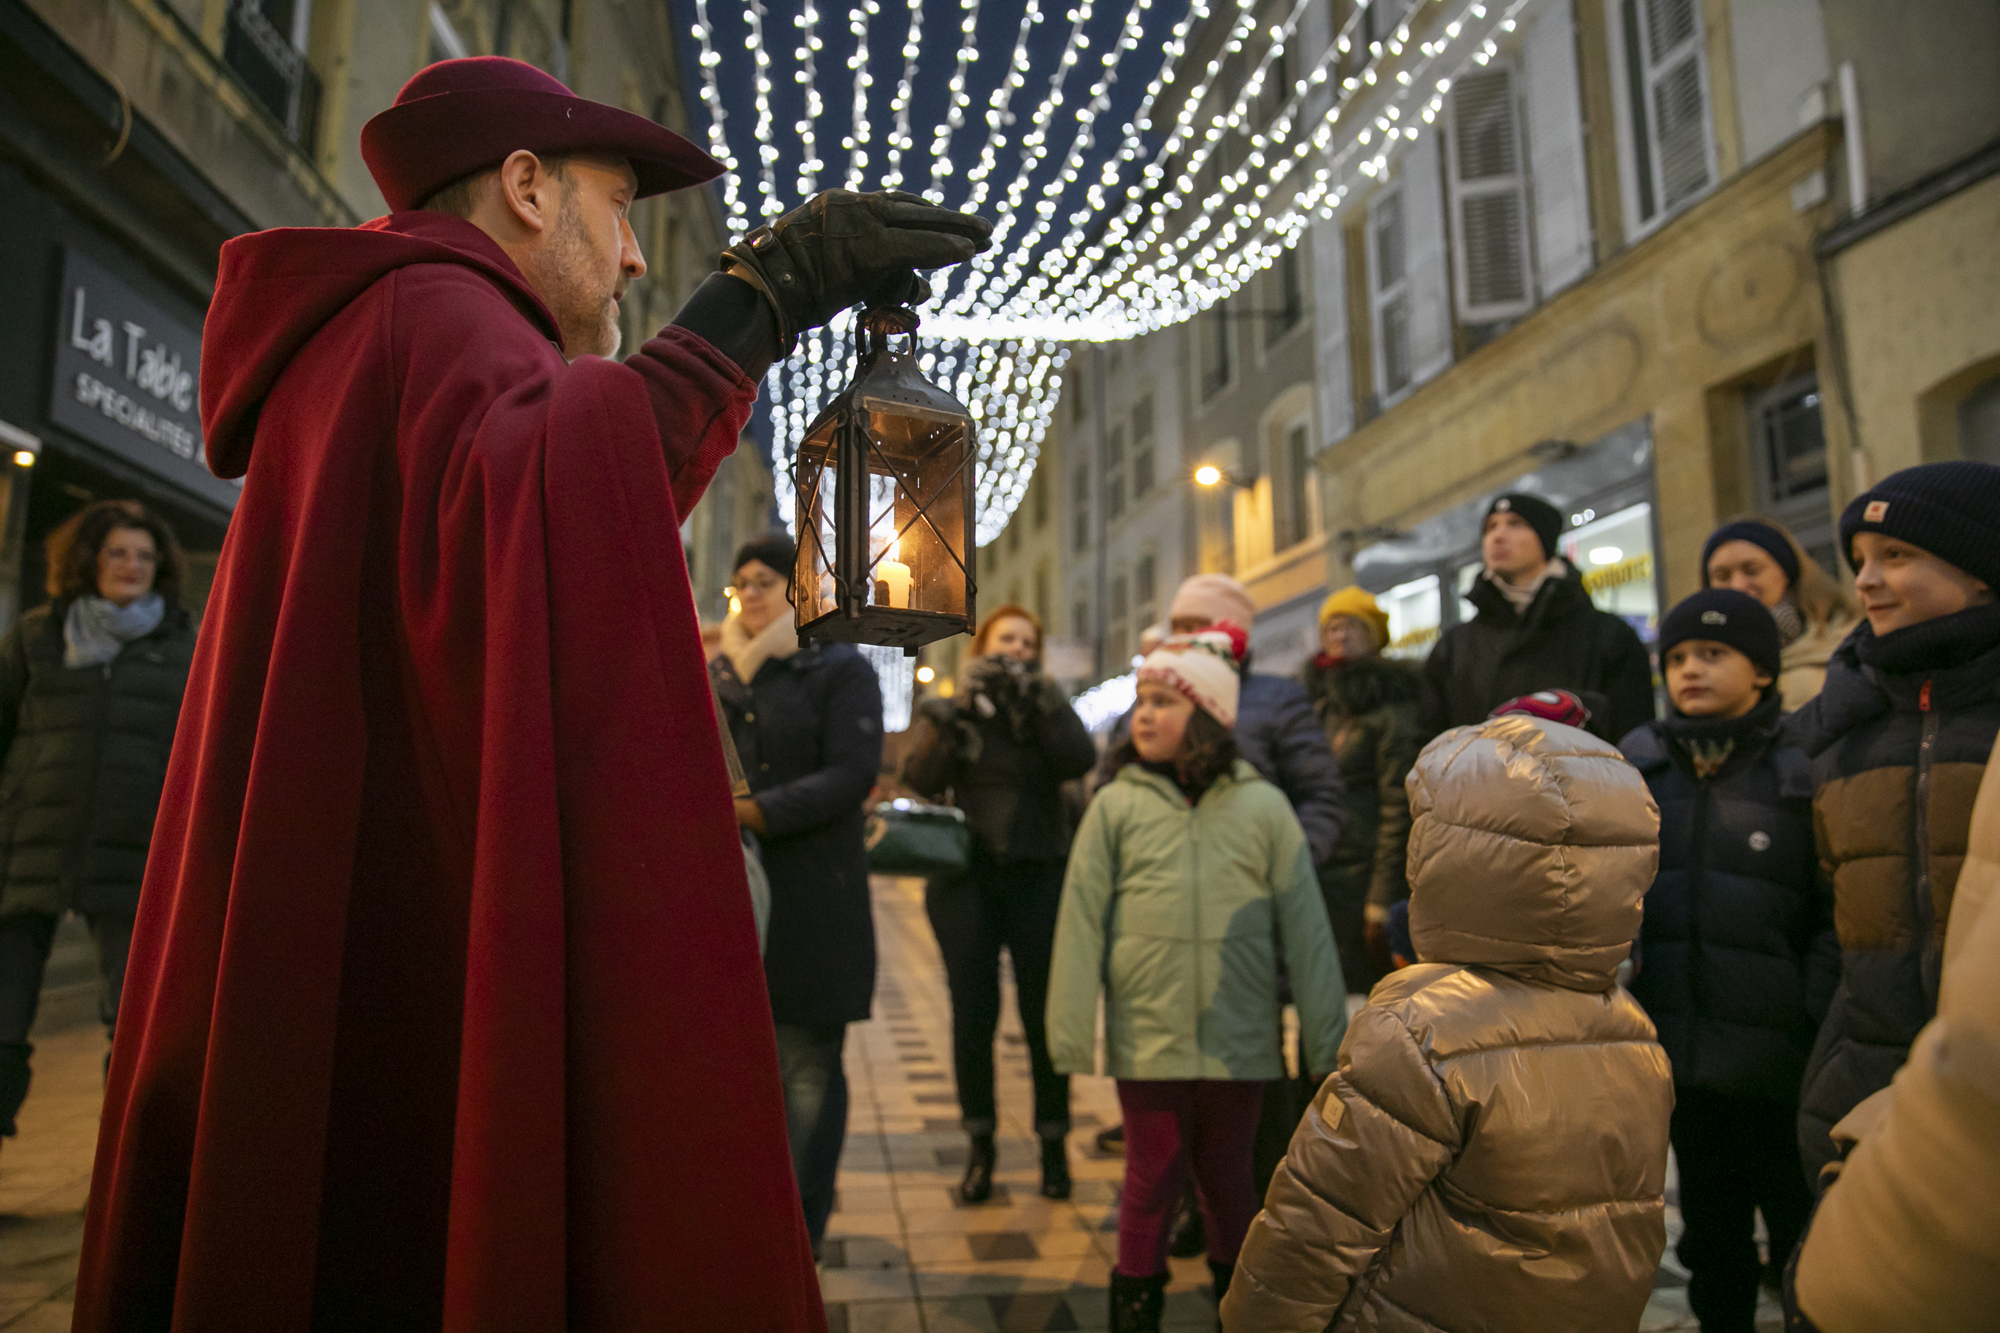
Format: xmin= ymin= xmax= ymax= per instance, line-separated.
xmin=1610 ymin=0 xmax=1716 ymax=230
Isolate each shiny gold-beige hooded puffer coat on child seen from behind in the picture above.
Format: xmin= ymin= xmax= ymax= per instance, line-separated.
xmin=1222 ymin=717 xmax=1674 ymax=1333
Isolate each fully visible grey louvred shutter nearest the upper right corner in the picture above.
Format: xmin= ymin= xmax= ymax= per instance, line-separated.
xmin=1446 ymin=64 xmax=1534 ymax=324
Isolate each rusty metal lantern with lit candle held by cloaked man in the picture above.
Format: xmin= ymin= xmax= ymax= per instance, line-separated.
xmin=792 ymin=306 xmax=976 ymax=656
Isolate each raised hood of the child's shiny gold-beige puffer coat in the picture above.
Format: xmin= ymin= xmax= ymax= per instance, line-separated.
xmin=1408 ymin=715 xmax=1660 ymax=991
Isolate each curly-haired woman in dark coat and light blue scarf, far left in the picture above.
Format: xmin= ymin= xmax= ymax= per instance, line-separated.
xmin=0 ymin=500 xmax=194 ymax=1135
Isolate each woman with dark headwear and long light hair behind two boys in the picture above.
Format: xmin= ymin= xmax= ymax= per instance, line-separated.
xmin=1702 ymin=518 xmax=1860 ymax=713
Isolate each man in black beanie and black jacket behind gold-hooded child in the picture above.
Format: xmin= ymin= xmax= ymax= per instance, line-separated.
xmin=1418 ymin=492 xmax=1654 ymax=741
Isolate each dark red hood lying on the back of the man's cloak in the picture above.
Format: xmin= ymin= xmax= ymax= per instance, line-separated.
xmin=202 ymin=212 xmax=562 ymax=478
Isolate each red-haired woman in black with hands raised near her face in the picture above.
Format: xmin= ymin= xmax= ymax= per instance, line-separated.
xmin=902 ymin=606 xmax=1098 ymax=1203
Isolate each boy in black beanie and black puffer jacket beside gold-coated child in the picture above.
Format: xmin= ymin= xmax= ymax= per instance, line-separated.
xmin=1620 ymin=588 xmax=1838 ymax=1333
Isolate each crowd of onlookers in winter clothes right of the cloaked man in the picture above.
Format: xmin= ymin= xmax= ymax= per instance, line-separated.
xmin=712 ymin=452 xmax=2000 ymax=1333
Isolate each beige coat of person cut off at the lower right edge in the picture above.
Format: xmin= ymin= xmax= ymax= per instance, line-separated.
xmin=1798 ymin=761 xmax=2000 ymax=1333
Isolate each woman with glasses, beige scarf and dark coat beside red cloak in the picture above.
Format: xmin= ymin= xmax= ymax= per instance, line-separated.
xmin=708 ymin=536 xmax=882 ymax=1251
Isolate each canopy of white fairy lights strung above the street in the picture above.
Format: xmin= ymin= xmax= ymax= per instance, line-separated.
xmin=692 ymin=0 xmax=1532 ymax=542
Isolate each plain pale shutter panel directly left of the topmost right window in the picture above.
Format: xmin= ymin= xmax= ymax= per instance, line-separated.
xmin=1520 ymin=4 xmax=1594 ymax=300
